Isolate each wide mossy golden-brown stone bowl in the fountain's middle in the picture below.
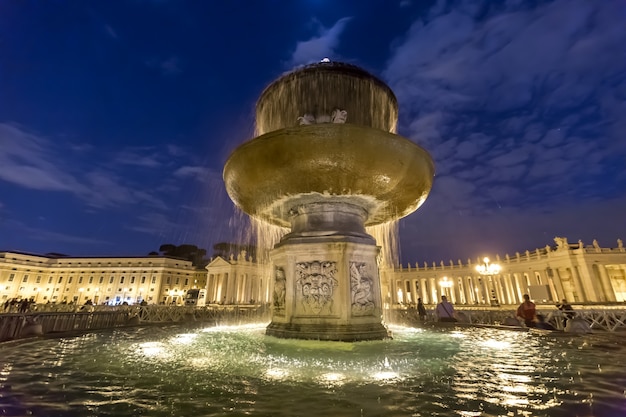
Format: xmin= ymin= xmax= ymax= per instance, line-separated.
xmin=223 ymin=123 xmax=435 ymax=227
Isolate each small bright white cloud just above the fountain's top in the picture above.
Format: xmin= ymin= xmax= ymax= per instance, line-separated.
xmin=289 ymin=17 xmax=351 ymax=67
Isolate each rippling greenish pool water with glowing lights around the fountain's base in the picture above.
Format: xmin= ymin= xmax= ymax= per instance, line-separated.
xmin=0 ymin=325 xmax=626 ymax=417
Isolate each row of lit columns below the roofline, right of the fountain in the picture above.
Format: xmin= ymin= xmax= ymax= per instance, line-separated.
xmin=381 ymin=254 xmax=626 ymax=306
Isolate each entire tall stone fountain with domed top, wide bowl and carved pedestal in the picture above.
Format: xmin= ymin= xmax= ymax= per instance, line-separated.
xmin=224 ymin=60 xmax=434 ymax=341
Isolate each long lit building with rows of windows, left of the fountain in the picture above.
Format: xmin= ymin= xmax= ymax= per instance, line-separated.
xmin=0 ymin=252 xmax=206 ymax=305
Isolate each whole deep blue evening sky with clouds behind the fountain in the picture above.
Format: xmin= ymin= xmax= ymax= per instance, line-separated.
xmin=0 ymin=0 xmax=626 ymax=263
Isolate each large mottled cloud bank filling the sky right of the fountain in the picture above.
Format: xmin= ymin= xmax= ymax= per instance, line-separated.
xmin=384 ymin=0 xmax=626 ymax=213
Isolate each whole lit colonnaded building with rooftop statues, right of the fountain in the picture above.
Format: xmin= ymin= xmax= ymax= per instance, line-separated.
xmin=381 ymin=238 xmax=626 ymax=306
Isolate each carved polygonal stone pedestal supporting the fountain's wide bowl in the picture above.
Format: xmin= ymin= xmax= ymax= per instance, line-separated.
xmin=266 ymin=202 xmax=389 ymax=341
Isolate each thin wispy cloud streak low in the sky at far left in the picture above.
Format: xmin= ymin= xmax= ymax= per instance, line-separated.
xmin=0 ymin=123 xmax=183 ymax=210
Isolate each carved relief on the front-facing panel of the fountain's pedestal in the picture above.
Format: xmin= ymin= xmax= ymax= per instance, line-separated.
xmin=296 ymin=261 xmax=338 ymax=316
